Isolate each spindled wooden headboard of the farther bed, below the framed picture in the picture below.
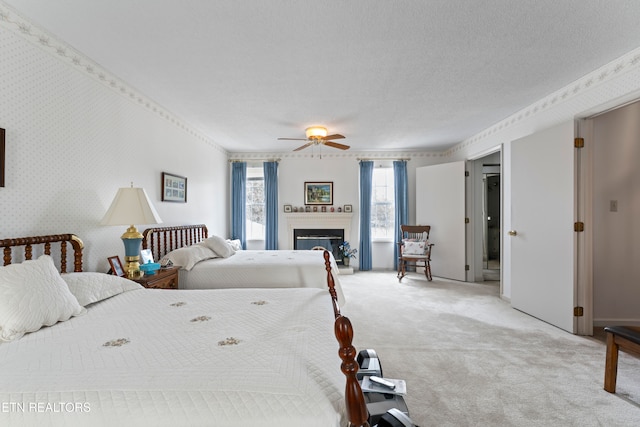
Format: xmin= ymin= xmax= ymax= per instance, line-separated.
xmin=142 ymin=224 xmax=209 ymax=262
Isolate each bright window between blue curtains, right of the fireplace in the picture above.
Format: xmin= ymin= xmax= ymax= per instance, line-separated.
xmin=371 ymin=167 xmax=395 ymax=239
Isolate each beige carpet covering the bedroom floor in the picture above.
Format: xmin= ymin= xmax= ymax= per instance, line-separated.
xmin=340 ymin=271 xmax=640 ymax=427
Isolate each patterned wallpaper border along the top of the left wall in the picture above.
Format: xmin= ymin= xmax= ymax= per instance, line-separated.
xmin=0 ymin=2 xmax=228 ymax=155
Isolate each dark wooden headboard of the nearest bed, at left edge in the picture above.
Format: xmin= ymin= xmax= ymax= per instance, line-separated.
xmin=0 ymin=234 xmax=84 ymax=273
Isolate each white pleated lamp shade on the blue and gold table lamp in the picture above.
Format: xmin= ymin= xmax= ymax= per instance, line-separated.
xmin=100 ymin=187 xmax=162 ymax=225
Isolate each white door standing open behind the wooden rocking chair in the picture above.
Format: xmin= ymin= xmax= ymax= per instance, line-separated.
xmin=416 ymin=162 xmax=466 ymax=281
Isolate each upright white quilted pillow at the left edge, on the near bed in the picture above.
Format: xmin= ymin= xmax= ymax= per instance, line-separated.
xmin=0 ymin=255 xmax=86 ymax=341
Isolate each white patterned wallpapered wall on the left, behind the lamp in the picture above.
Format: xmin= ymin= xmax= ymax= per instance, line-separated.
xmin=0 ymin=21 xmax=229 ymax=271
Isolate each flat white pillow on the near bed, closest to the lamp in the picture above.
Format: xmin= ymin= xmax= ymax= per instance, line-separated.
xmin=62 ymin=273 xmax=142 ymax=306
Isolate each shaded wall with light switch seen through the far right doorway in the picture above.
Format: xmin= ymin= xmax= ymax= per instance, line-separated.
xmin=592 ymin=103 xmax=640 ymax=325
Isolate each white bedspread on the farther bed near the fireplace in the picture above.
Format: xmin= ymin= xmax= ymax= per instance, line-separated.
xmin=179 ymin=250 xmax=345 ymax=306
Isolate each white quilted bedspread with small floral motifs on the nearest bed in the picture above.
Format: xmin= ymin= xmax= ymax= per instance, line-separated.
xmin=0 ymin=288 xmax=346 ymax=427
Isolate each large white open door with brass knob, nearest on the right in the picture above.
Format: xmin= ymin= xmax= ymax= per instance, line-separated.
xmin=505 ymin=122 xmax=576 ymax=333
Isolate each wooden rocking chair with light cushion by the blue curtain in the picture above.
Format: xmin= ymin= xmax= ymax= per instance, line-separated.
xmin=398 ymin=225 xmax=433 ymax=282
